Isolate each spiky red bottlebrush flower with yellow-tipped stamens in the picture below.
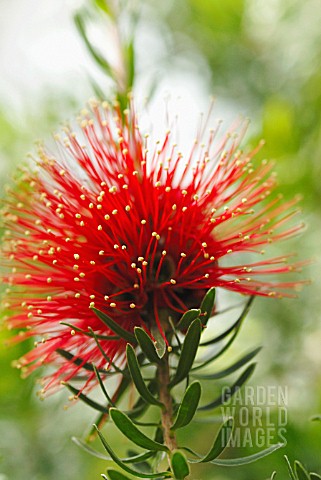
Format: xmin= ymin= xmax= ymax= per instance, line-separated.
xmin=1 ymin=103 xmax=300 ymax=390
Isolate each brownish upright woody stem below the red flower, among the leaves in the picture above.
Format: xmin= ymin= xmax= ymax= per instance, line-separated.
xmin=158 ymin=355 xmax=177 ymax=452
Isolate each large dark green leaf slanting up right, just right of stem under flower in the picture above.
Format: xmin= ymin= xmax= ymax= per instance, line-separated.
xmin=169 ymin=318 xmax=202 ymax=388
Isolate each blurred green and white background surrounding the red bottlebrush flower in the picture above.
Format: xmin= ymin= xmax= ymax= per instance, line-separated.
xmin=0 ymin=0 xmax=321 ymax=480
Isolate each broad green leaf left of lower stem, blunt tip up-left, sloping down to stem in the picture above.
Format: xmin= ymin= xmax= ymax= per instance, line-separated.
xmin=109 ymin=408 xmax=168 ymax=452
